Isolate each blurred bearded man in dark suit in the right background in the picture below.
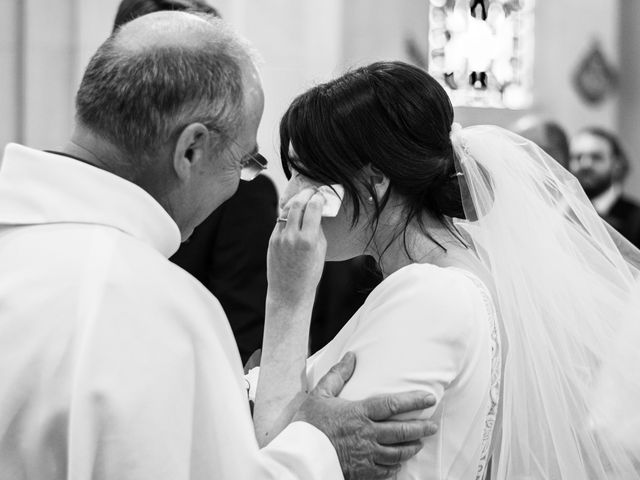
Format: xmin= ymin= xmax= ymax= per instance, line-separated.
xmin=569 ymin=127 xmax=640 ymax=247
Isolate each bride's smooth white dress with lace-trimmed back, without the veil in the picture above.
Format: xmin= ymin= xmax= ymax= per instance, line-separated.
xmin=247 ymin=264 xmax=501 ymax=480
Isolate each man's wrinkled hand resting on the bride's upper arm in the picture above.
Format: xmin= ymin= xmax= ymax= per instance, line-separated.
xmin=293 ymin=353 xmax=437 ymax=480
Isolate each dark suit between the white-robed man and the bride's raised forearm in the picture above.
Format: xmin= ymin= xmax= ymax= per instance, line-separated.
xmin=170 ymin=175 xmax=278 ymax=363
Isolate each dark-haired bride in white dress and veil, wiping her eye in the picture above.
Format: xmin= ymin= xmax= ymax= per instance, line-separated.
xmin=249 ymin=62 xmax=638 ymax=480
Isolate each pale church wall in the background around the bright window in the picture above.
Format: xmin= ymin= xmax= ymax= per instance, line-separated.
xmin=0 ymin=0 xmax=640 ymax=199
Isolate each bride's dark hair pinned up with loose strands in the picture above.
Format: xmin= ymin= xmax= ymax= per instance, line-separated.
xmin=280 ymin=62 xmax=464 ymax=260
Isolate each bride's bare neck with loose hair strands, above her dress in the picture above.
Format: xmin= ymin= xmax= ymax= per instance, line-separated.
xmin=371 ymin=211 xmax=477 ymax=277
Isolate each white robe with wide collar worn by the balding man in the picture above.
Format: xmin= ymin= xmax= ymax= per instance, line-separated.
xmin=0 ymin=145 xmax=341 ymax=480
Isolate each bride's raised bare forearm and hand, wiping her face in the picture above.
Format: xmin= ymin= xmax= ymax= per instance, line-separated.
xmin=253 ymin=190 xmax=326 ymax=447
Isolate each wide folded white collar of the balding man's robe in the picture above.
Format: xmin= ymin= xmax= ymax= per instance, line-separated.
xmin=0 ymin=143 xmax=180 ymax=258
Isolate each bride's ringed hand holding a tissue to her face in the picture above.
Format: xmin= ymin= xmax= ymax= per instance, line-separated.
xmin=267 ymin=189 xmax=327 ymax=307
